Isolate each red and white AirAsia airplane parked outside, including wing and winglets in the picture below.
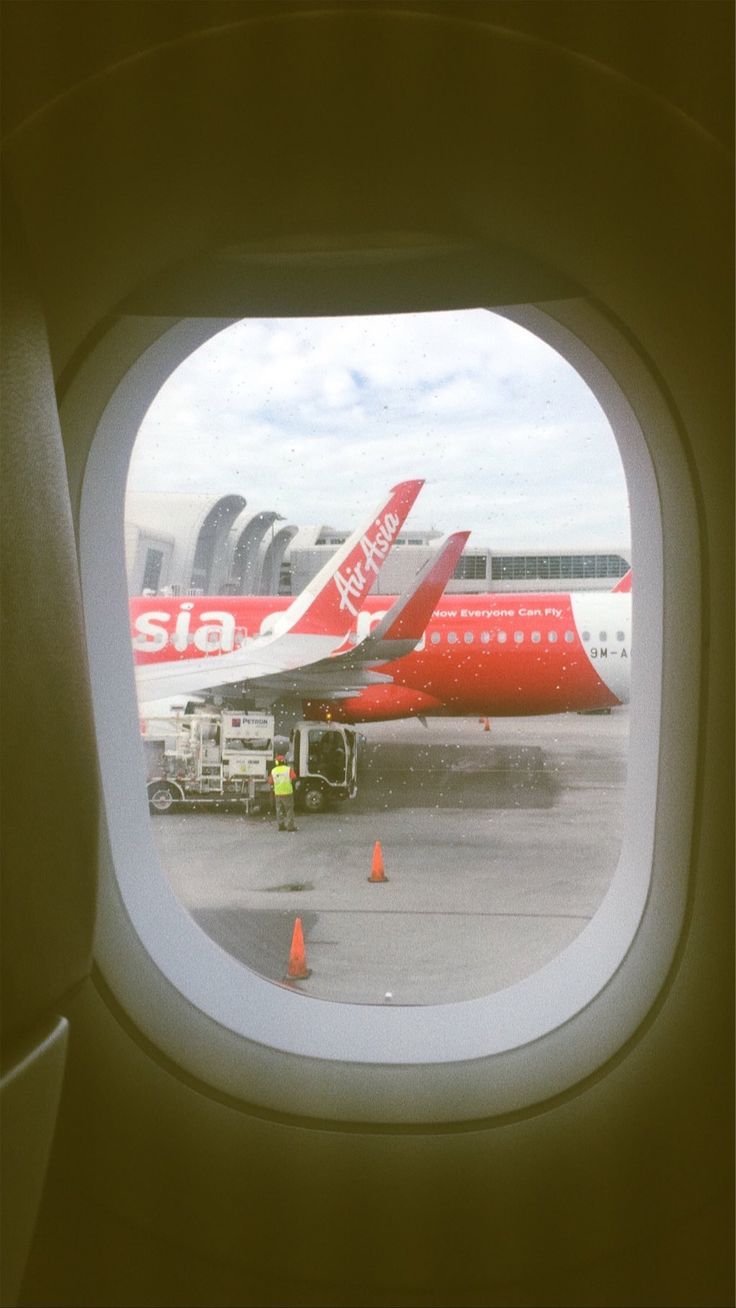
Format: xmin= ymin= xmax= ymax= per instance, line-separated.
xmin=131 ymin=481 xmax=631 ymax=722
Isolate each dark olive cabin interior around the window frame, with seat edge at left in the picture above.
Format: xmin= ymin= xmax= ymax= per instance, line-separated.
xmin=3 ymin=0 xmax=733 ymax=1308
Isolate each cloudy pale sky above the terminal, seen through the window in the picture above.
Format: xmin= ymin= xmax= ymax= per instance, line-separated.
xmin=128 ymin=309 xmax=629 ymax=551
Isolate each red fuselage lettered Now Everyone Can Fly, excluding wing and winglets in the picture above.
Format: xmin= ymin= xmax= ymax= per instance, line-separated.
xmin=131 ymin=591 xmax=631 ymax=722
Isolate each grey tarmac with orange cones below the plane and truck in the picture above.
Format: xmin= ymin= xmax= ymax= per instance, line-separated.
xmin=152 ymin=709 xmax=629 ymax=1005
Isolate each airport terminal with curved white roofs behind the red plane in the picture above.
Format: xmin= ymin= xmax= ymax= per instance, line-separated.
xmin=125 ymin=492 xmax=631 ymax=595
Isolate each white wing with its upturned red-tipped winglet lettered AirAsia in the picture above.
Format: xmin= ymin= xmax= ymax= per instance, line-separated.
xmin=136 ymin=480 xmax=424 ymax=702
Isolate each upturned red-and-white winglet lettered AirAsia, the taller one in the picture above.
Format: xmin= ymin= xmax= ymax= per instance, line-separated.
xmin=273 ymin=480 xmax=424 ymax=636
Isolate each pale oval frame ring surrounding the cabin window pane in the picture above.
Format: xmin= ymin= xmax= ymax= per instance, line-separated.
xmin=74 ymin=300 xmax=701 ymax=1124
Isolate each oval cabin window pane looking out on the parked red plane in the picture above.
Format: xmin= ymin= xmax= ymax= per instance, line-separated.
xmin=125 ymin=310 xmax=631 ymax=1005
